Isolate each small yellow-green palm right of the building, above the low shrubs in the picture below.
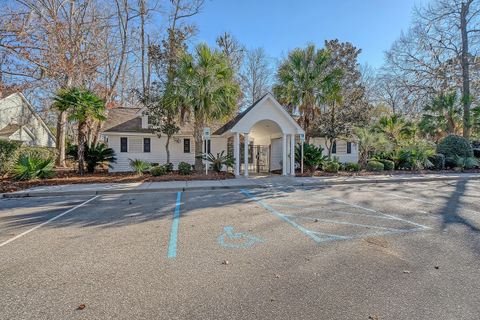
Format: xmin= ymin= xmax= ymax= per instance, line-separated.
xmin=375 ymin=114 xmax=414 ymax=146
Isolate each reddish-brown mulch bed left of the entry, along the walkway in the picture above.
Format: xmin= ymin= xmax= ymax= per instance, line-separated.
xmin=0 ymin=171 xmax=235 ymax=193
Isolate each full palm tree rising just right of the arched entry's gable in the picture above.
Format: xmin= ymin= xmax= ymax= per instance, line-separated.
xmin=273 ymin=44 xmax=341 ymax=139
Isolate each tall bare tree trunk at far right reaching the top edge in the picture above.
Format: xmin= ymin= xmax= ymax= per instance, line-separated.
xmin=460 ymin=1 xmax=472 ymax=139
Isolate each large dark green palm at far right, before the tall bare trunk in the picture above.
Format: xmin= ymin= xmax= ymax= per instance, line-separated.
xmin=418 ymin=92 xmax=463 ymax=141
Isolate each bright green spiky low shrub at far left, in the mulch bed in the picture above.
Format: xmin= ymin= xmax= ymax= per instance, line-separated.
xmin=13 ymin=156 xmax=54 ymax=180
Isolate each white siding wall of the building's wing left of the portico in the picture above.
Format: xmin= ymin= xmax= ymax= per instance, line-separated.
xmin=109 ymin=133 xmax=227 ymax=172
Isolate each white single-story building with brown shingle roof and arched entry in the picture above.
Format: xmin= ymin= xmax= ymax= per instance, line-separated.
xmin=102 ymin=94 xmax=358 ymax=176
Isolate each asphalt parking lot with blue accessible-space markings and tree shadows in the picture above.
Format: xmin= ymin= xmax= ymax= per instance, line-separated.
xmin=0 ymin=180 xmax=480 ymax=319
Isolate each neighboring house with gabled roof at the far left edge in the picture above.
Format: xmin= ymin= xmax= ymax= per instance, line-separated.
xmin=0 ymin=93 xmax=55 ymax=147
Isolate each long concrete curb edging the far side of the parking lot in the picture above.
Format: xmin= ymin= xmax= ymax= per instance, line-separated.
xmin=1 ymin=175 xmax=480 ymax=199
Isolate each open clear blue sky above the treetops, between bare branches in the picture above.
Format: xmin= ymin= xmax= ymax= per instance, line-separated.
xmin=190 ymin=0 xmax=429 ymax=68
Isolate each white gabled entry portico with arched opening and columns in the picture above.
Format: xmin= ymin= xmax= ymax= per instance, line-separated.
xmin=214 ymin=94 xmax=305 ymax=176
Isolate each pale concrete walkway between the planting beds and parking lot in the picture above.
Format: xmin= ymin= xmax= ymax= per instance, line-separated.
xmin=0 ymin=173 xmax=480 ymax=198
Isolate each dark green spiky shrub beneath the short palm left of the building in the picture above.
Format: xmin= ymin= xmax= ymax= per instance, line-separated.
xmin=66 ymin=143 xmax=117 ymax=173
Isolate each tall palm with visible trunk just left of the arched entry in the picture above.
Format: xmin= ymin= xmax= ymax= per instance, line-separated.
xmin=176 ymin=44 xmax=240 ymax=171
